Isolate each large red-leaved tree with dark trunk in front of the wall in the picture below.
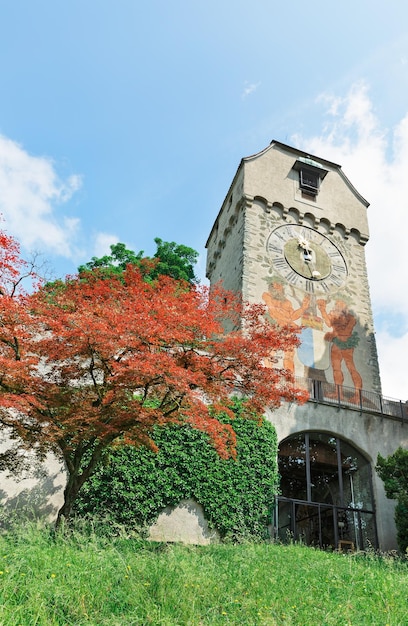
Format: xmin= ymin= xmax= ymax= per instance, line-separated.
xmin=0 ymin=243 xmax=306 ymax=524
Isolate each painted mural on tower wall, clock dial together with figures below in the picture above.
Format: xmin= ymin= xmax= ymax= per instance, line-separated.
xmin=261 ymin=222 xmax=363 ymax=389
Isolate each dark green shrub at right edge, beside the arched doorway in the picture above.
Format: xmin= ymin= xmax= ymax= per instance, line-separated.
xmin=376 ymin=447 xmax=408 ymax=553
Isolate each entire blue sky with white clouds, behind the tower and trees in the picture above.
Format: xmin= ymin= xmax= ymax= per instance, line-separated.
xmin=0 ymin=0 xmax=408 ymax=398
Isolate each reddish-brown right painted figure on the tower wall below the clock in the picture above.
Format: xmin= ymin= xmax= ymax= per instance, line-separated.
xmin=317 ymin=300 xmax=363 ymax=389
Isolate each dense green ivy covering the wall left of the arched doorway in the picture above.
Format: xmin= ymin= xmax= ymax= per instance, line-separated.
xmin=75 ymin=401 xmax=278 ymax=539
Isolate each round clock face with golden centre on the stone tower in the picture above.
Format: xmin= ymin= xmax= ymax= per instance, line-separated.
xmin=266 ymin=224 xmax=347 ymax=293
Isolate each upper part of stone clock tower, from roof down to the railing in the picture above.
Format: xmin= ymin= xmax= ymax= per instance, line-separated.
xmin=207 ymin=141 xmax=381 ymax=393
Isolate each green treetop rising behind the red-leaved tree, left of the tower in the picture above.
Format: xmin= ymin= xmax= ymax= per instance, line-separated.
xmin=78 ymin=237 xmax=198 ymax=284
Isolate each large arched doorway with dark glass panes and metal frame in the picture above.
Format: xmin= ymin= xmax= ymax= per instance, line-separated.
xmin=274 ymin=432 xmax=378 ymax=550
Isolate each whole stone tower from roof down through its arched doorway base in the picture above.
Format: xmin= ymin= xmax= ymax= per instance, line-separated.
xmin=207 ymin=141 xmax=408 ymax=549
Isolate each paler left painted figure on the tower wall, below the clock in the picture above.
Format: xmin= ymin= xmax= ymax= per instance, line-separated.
xmin=262 ymin=282 xmax=310 ymax=374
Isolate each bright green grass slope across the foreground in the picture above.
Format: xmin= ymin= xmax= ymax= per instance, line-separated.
xmin=0 ymin=525 xmax=408 ymax=626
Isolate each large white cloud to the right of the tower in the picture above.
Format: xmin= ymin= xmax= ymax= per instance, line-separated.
xmin=292 ymin=83 xmax=408 ymax=398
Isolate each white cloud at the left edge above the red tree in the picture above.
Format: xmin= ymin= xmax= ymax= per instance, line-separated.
xmin=0 ymin=135 xmax=81 ymax=258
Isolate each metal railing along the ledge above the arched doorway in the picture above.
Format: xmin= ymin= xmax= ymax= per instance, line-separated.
xmin=295 ymin=377 xmax=408 ymax=423
